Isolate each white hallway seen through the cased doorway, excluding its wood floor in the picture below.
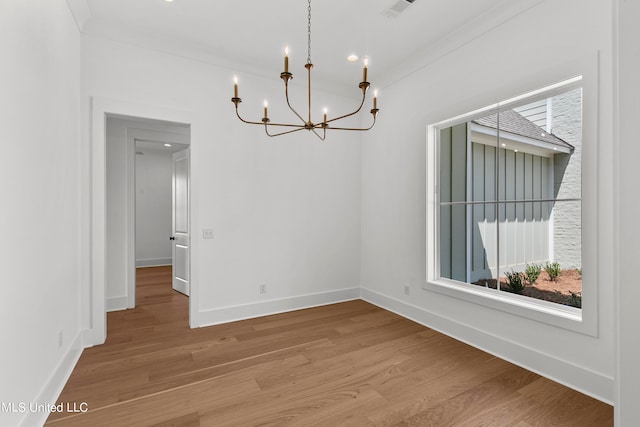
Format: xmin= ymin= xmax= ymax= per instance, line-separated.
xmin=105 ymin=114 xmax=190 ymax=311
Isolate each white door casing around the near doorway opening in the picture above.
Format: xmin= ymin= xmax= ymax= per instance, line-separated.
xmin=83 ymin=97 xmax=200 ymax=346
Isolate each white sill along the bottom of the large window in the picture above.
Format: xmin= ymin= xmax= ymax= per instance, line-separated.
xmin=422 ymin=279 xmax=597 ymax=336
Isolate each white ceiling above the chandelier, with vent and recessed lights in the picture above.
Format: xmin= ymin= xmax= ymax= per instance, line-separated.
xmin=68 ymin=0 xmax=541 ymax=93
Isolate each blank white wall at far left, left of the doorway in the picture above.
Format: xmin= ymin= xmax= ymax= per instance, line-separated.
xmin=0 ymin=0 xmax=82 ymax=426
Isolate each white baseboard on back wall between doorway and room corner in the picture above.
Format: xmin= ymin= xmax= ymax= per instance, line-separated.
xmin=198 ymin=288 xmax=360 ymax=327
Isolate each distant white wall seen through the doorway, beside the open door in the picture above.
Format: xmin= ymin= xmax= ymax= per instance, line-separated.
xmin=136 ymin=145 xmax=173 ymax=267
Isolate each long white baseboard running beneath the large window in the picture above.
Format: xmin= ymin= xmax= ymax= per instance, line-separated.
xmin=360 ymin=288 xmax=614 ymax=405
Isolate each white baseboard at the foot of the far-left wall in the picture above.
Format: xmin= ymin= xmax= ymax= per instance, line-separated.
xmin=20 ymin=333 xmax=83 ymax=426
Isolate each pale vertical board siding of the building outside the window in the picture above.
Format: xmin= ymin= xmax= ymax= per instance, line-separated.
xmin=440 ymin=119 xmax=553 ymax=282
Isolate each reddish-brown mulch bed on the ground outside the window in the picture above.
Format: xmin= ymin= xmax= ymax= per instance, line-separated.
xmin=474 ymin=269 xmax=582 ymax=307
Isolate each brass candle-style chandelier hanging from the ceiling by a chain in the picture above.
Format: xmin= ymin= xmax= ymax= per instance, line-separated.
xmin=231 ymin=0 xmax=379 ymax=141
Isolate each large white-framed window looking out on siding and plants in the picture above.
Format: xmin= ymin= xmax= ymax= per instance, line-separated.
xmin=427 ymin=77 xmax=596 ymax=332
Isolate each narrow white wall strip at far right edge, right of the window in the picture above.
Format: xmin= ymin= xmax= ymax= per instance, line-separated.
xmin=614 ymin=0 xmax=640 ymax=426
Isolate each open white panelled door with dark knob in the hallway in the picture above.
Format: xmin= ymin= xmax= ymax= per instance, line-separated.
xmin=171 ymin=148 xmax=190 ymax=295
